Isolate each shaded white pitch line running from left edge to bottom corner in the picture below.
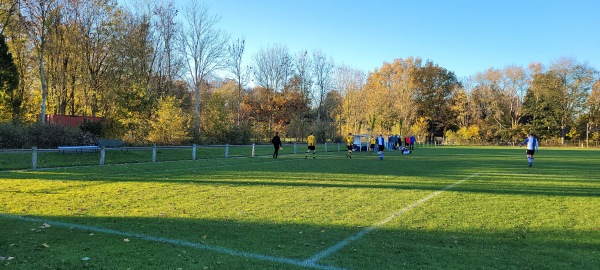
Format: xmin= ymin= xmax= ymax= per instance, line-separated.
xmin=0 ymin=214 xmax=343 ymax=270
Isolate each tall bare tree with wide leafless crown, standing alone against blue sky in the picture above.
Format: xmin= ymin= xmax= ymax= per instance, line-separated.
xmin=181 ymin=1 xmax=229 ymax=142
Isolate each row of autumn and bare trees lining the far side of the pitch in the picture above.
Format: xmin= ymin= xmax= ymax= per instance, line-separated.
xmin=0 ymin=0 xmax=600 ymax=147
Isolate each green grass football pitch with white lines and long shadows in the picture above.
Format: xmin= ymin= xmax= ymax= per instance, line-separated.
xmin=0 ymin=147 xmax=600 ymax=269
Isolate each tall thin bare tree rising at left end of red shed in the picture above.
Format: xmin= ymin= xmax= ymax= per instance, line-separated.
xmin=21 ymin=0 xmax=58 ymax=123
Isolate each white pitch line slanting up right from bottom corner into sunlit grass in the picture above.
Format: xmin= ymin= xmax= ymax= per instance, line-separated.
xmin=304 ymin=173 xmax=479 ymax=265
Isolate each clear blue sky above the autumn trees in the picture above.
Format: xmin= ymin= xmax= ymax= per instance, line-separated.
xmin=183 ymin=0 xmax=600 ymax=78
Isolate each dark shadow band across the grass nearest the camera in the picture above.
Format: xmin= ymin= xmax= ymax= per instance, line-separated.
xmin=0 ymin=216 xmax=600 ymax=269
